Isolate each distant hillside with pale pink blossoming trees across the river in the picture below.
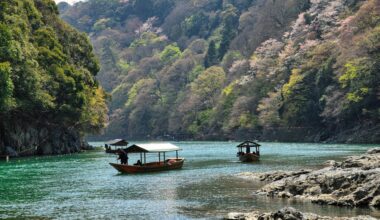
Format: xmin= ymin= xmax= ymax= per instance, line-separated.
xmin=59 ymin=0 xmax=380 ymax=142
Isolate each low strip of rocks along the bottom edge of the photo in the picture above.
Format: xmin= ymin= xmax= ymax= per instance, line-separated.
xmin=225 ymin=207 xmax=376 ymax=220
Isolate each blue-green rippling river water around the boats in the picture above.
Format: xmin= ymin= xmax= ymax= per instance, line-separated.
xmin=0 ymin=142 xmax=380 ymax=219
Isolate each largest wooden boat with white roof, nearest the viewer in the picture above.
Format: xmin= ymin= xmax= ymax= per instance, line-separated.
xmin=110 ymin=143 xmax=184 ymax=174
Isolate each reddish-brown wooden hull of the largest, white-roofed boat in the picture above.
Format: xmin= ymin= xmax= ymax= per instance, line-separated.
xmin=110 ymin=159 xmax=184 ymax=174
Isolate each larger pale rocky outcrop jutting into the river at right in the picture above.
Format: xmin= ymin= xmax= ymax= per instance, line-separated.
xmin=240 ymin=148 xmax=380 ymax=208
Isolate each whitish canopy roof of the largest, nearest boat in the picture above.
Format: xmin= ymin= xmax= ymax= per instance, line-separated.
xmin=126 ymin=143 xmax=182 ymax=153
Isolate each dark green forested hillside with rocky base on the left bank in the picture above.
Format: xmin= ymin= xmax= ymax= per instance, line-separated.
xmin=0 ymin=0 xmax=107 ymax=156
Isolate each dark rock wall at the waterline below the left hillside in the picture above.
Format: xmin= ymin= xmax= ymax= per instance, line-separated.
xmin=0 ymin=117 xmax=87 ymax=156
